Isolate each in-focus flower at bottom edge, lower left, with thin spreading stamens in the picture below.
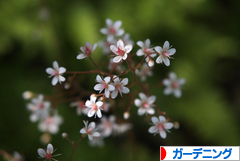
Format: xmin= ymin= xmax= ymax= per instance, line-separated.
xmin=37 ymin=143 xmax=61 ymax=161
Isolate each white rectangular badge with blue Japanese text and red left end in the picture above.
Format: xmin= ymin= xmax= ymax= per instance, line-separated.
xmin=160 ymin=146 xmax=239 ymax=161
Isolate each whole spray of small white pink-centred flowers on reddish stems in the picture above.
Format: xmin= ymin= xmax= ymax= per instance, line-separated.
xmin=21 ymin=19 xmax=185 ymax=160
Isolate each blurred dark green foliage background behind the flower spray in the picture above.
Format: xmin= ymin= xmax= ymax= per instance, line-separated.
xmin=0 ymin=0 xmax=240 ymax=161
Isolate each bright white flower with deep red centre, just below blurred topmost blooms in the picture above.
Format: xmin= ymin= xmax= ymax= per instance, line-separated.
xmin=110 ymin=39 xmax=132 ymax=63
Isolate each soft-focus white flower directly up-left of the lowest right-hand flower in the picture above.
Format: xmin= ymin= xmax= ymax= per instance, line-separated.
xmin=134 ymin=93 xmax=156 ymax=116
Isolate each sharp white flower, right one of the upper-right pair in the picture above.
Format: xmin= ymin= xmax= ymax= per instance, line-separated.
xmin=155 ymin=41 xmax=176 ymax=66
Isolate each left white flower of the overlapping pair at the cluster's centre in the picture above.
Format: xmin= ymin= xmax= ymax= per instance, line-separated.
xmin=94 ymin=75 xmax=115 ymax=98
